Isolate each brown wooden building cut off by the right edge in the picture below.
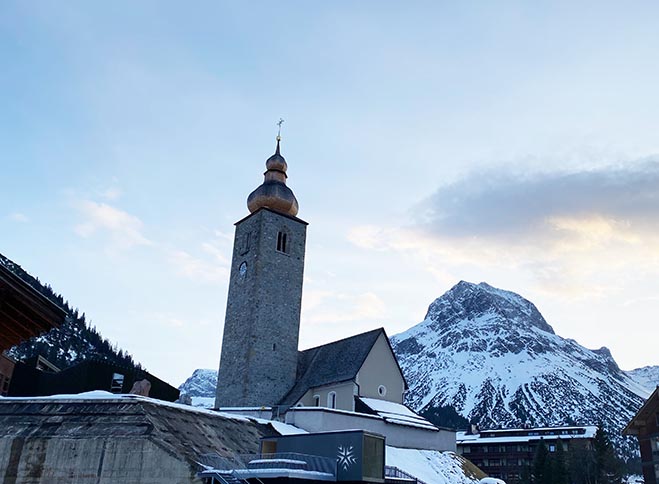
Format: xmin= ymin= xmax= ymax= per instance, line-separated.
xmin=622 ymin=386 xmax=659 ymax=484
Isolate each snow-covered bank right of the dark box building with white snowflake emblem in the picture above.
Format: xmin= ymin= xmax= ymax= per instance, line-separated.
xmin=385 ymin=446 xmax=478 ymax=484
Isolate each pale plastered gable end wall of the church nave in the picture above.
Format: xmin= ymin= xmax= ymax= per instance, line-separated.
xmin=357 ymin=334 xmax=405 ymax=403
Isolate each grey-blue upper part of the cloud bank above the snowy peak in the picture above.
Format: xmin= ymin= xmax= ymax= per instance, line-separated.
xmin=415 ymin=160 xmax=659 ymax=239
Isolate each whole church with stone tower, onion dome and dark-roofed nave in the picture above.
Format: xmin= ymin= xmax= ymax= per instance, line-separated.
xmin=215 ymin=136 xmax=407 ymax=411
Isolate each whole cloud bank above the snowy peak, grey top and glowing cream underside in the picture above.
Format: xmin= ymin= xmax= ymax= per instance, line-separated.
xmin=349 ymin=160 xmax=659 ymax=298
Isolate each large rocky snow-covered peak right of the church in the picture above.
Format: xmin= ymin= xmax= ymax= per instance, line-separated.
xmin=391 ymin=281 xmax=648 ymax=453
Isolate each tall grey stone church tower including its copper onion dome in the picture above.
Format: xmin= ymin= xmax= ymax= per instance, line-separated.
xmin=215 ymin=136 xmax=307 ymax=407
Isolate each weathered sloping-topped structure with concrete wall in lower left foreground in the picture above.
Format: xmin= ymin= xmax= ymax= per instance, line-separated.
xmin=0 ymin=394 xmax=277 ymax=484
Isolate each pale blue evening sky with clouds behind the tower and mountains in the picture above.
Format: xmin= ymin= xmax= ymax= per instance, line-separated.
xmin=0 ymin=0 xmax=659 ymax=386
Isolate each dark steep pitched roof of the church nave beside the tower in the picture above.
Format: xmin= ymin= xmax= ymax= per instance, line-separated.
xmin=281 ymin=328 xmax=388 ymax=406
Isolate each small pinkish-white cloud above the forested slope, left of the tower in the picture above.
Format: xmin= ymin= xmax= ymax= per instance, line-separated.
xmin=74 ymin=200 xmax=152 ymax=249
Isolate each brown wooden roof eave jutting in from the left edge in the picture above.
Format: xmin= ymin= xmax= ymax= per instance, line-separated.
xmin=0 ymin=254 xmax=66 ymax=351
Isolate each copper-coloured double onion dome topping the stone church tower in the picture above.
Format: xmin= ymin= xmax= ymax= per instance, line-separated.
xmin=247 ymin=136 xmax=299 ymax=216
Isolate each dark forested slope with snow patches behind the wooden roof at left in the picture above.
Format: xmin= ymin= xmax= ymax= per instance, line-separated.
xmin=0 ymin=254 xmax=142 ymax=370
